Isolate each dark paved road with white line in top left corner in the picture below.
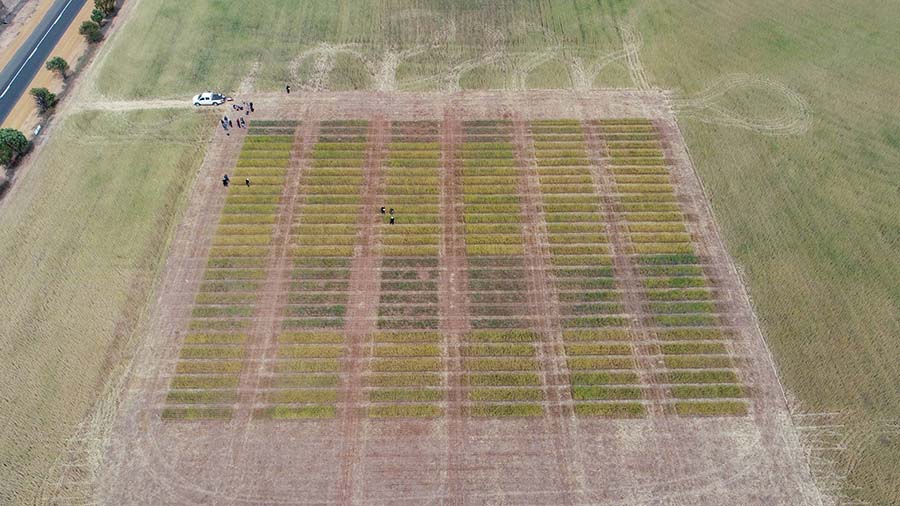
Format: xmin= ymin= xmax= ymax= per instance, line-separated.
xmin=0 ymin=0 xmax=86 ymax=122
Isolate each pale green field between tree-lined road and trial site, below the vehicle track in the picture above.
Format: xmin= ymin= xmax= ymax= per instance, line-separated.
xmin=0 ymin=111 xmax=210 ymax=503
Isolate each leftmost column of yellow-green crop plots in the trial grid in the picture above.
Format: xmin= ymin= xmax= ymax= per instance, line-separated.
xmin=162 ymin=124 xmax=296 ymax=420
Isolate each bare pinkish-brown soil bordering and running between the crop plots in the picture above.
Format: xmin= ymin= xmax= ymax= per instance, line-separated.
xmin=93 ymin=91 xmax=820 ymax=506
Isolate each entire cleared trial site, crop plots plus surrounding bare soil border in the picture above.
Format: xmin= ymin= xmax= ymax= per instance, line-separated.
xmin=93 ymin=91 xmax=818 ymax=505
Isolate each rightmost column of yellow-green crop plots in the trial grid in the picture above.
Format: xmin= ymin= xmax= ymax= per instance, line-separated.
xmin=595 ymin=119 xmax=749 ymax=416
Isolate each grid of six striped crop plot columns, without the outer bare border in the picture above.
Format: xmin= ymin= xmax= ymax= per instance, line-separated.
xmin=161 ymin=118 xmax=751 ymax=421
